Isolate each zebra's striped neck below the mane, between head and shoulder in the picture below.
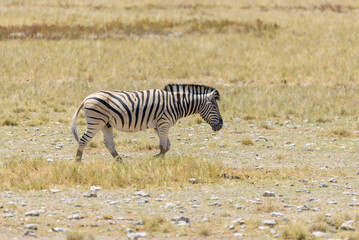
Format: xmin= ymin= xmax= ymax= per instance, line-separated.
xmin=172 ymin=93 xmax=205 ymax=120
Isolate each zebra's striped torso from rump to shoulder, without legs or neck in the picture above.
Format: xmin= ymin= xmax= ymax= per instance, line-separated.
xmin=84 ymin=89 xmax=167 ymax=132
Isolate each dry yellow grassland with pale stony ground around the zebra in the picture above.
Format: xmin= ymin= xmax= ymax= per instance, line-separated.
xmin=0 ymin=0 xmax=359 ymax=239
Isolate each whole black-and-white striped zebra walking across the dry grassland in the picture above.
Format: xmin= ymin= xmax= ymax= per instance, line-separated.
xmin=71 ymin=84 xmax=223 ymax=162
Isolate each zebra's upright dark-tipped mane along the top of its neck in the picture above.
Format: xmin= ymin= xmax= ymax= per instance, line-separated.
xmin=163 ymin=84 xmax=221 ymax=101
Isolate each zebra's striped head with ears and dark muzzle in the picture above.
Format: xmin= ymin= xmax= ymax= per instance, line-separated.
xmin=200 ymin=90 xmax=223 ymax=131
